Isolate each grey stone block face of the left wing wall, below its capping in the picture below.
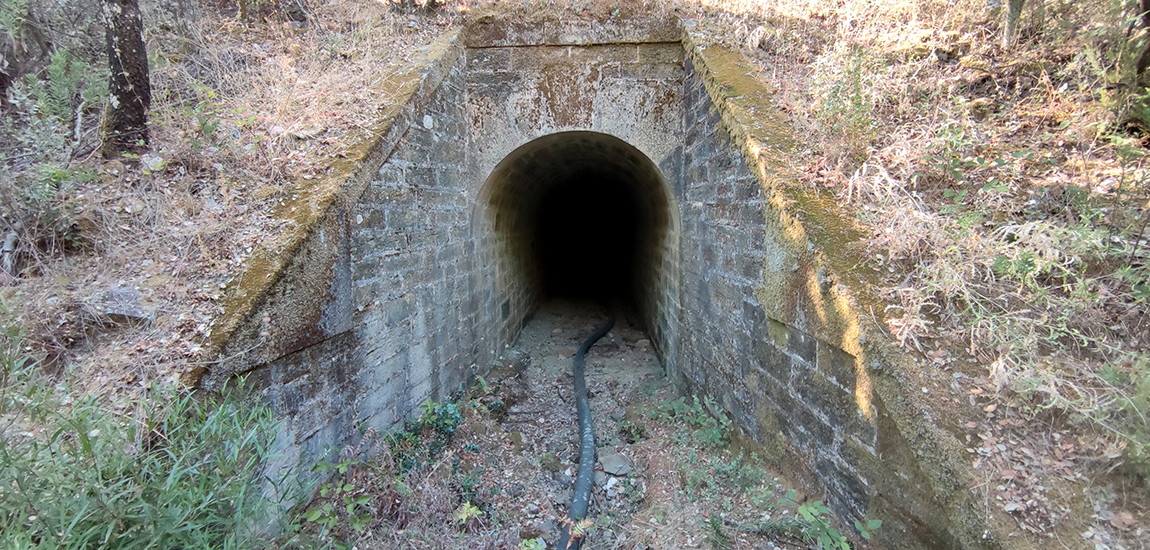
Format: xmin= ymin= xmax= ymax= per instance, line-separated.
xmin=244 ymin=41 xmax=487 ymax=484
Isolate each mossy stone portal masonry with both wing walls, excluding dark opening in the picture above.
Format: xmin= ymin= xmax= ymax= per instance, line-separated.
xmin=211 ymin=19 xmax=1002 ymax=548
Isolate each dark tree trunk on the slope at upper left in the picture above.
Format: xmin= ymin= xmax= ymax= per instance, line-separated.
xmin=102 ymin=0 xmax=152 ymax=158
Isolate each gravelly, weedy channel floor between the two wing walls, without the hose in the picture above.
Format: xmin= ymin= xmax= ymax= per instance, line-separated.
xmin=301 ymin=300 xmax=809 ymax=549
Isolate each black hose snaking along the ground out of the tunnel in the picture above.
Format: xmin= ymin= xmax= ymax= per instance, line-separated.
xmin=559 ymin=318 xmax=615 ymax=550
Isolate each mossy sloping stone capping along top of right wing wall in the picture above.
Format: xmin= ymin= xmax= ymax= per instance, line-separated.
xmin=682 ymin=20 xmax=1009 ymax=549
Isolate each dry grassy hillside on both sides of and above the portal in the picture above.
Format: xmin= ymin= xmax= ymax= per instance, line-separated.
xmin=0 ymin=0 xmax=1150 ymax=548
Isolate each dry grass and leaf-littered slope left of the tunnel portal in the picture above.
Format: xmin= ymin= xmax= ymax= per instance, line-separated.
xmin=2 ymin=1 xmax=449 ymax=396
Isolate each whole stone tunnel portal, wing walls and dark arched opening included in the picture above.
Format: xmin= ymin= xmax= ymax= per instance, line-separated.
xmin=202 ymin=29 xmax=983 ymax=548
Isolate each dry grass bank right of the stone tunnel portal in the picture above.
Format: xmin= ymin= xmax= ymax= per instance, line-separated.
xmin=733 ymin=1 xmax=1150 ymax=548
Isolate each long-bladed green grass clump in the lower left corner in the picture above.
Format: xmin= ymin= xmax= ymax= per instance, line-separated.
xmin=0 ymin=308 xmax=275 ymax=549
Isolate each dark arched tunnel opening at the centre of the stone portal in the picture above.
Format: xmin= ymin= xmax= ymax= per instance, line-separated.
xmin=481 ymin=131 xmax=673 ymax=333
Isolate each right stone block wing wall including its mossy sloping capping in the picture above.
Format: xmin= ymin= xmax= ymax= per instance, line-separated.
xmin=664 ymin=37 xmax=989 ymax=549
